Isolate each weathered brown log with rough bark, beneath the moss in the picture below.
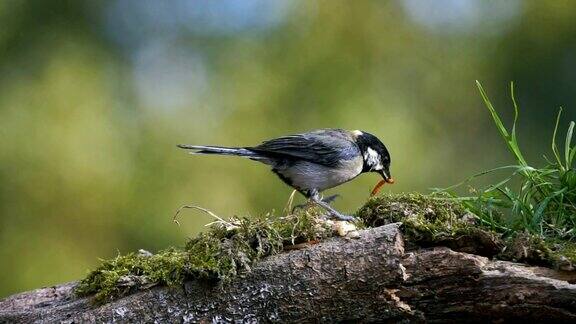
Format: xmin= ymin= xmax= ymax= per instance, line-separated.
xmin=0 ymin=224 xmax=576 ymax=323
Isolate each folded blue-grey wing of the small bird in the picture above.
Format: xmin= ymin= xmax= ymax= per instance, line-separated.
xmin=247 ymin=129 xmax=360 ymax=166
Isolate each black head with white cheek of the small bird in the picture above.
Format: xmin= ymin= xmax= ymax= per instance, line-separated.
xmin=352 ymin=131 xmax=393 ymax=182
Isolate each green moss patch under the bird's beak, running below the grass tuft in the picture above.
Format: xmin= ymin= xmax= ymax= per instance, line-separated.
xmin=357 ymin=194 xmax=576 ymax=271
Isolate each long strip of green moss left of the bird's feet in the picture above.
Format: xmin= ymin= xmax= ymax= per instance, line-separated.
xmin=76 ymin=209 xmax=332 ymax=303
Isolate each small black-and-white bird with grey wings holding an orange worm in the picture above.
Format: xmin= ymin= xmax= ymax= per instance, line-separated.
xmin=178 ymin=129 xmax=393 ymax=220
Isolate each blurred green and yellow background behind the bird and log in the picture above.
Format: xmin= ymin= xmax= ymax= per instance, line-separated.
xmin=0 ymin=0 xmax=576 ymax=297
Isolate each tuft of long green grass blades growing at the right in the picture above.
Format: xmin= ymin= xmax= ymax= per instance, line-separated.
xmin=436 ymin=82 xmax=576 ymax=240
